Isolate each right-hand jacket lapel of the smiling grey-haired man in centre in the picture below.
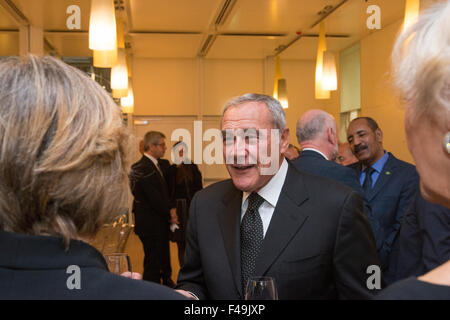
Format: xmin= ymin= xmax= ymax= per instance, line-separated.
xmin=255 ymin=165 xmax=308 ymax=275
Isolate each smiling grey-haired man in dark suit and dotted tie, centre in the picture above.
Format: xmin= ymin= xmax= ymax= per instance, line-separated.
xmin=177 ymin=94 xmax=378 ymax=299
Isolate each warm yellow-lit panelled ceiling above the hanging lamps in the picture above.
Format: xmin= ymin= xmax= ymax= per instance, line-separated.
xmin=0 ymin=0 xmax=412 ymax=59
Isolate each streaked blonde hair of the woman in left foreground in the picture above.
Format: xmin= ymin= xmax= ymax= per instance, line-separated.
xmin=0 ymin=55 xmax=129 ymax=245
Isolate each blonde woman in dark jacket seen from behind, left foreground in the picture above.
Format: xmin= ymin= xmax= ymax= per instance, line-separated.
xmin=0 ymin=56 xmax=185 ymax=299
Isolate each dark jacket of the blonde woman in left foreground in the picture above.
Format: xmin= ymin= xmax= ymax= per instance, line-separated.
xmin=0 ymin=231 xmax=183 ymax=300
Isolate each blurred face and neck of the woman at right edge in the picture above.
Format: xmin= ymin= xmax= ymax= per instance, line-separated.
xmin=405 ymin=109 xmax=450 ymax=208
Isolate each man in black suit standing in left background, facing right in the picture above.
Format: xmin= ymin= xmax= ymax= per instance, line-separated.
xmin=130 ymin=131 xmax=177 ymax=287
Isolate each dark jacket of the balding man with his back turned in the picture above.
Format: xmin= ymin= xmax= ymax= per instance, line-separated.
xmin=293 ymin=150 xmax=381 ymax=248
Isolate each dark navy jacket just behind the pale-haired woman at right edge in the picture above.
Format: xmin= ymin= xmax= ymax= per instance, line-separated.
xmin=385 ymin=189 xmax=450 ymax=283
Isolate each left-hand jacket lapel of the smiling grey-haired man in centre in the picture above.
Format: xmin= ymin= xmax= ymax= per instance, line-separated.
xmin=219 ymin=186 xmax=242 ymax=296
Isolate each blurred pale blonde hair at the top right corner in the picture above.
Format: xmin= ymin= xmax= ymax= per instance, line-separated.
xmin=392 ymin=1 xmax=450 ymax=126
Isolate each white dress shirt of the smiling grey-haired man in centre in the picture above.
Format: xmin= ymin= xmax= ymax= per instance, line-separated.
xmin=241 ymin=159 xmax=288 ymax=237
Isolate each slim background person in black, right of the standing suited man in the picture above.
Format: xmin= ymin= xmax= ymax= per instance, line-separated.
xmin=169 ymin=141 xmax=203 ymax=266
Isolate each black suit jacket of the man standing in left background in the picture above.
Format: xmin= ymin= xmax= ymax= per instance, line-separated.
xmin=130 ymin=156 xmax=172 ymax=236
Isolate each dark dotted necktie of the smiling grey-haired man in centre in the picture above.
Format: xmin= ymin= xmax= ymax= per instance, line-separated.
xmin=241 ymin=192 xmax=264 ymax=291
